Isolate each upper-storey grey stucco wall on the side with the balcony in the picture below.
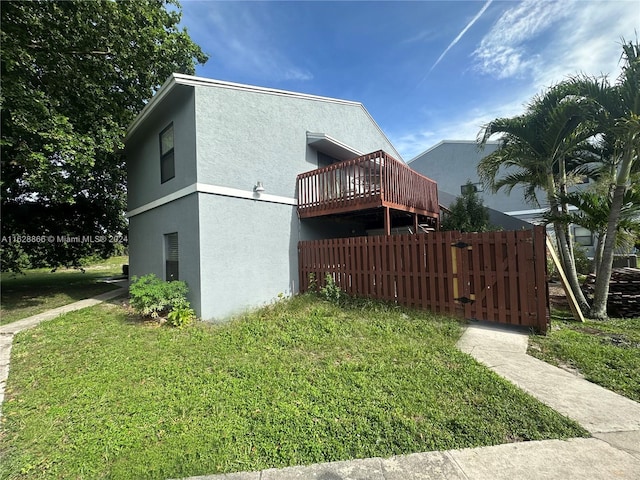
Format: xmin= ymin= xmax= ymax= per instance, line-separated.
xmin=195 ymin=87 xmax=395 ymax=198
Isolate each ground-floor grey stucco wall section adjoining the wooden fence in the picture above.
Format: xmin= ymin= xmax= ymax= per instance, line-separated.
xmin=198 ymin=193 xmax=298 ymax=320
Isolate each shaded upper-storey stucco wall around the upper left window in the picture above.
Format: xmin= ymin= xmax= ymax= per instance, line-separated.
xmin=125 ymin=86 xmax=196 ymax=211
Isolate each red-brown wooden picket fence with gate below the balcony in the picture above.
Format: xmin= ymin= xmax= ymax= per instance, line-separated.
xmin=298 ymin=227 xmax=549 ymax=332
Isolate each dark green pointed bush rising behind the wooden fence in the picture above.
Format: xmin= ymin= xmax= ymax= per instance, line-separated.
xmin=440 ymin=181 xmax=490 ymax=232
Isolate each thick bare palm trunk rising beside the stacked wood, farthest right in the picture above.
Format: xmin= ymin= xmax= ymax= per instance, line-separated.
xmin=590 ymin=146 xmax=634 ymax=320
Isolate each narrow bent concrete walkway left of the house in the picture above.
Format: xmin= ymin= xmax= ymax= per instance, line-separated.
xmin=0 ymin=280 xmax=128 ymax=417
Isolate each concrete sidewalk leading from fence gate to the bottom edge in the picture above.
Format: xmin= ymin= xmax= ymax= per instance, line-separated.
xmin=178 ymin=325 xmax=640 ymax=480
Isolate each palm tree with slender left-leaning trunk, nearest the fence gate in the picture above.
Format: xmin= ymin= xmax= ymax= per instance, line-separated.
xmin=478 ymin=84 xmax=594 ymax=313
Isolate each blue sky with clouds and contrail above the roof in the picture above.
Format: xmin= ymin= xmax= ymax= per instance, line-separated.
xmin=182 ymin=0 xmax=640 ymax=161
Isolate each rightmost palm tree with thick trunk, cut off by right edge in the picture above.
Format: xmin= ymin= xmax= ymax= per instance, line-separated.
xmin=568 ymin=40 xmax=640 ymax=319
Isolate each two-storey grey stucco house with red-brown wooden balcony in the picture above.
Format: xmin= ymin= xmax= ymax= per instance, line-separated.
xmin=125 ymin=74 xmax=438 ymax=319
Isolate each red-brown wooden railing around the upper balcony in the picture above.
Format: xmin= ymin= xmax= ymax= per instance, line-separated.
xmin=298 ymin=150 xmax=439 ymax=217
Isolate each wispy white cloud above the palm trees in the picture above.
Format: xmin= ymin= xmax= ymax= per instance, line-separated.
xmin=473 ymin=0 xmax=640 ymax=84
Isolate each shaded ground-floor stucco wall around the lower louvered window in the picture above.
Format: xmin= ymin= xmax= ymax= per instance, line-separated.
xmin=129 ymin=194 xmax=201 ymax=312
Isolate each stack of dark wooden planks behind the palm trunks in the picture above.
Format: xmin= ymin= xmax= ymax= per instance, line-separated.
xmin=583 ymin=268 xmax=640 ymax=318
